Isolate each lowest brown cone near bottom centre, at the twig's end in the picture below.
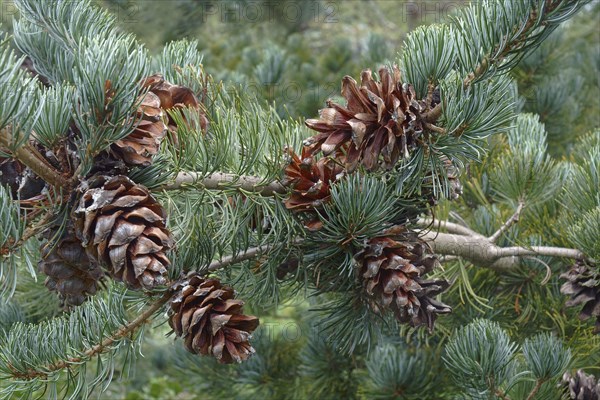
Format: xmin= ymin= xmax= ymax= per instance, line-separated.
xmin=169 ymin=275 xmax=258 ymax=364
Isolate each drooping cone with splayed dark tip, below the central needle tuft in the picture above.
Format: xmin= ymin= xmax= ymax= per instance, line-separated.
xmin=355 ymin=230 xmax=452 ymax=331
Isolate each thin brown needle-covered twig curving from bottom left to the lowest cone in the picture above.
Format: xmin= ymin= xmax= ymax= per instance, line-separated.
xmin=13 ymin=291 xmax=174 ymax=379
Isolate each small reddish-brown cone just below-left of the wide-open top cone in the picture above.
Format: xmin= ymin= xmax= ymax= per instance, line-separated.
xmin=285 ymin=147 xmax=343 ymax=212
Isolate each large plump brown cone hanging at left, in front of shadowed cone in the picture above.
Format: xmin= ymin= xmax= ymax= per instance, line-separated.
xmin=75 ymin=176 xmax=173 ymax=289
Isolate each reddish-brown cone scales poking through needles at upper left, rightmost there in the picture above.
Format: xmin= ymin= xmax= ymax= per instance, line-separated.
xmin=142 ymin=74 xmax=208 ymax=137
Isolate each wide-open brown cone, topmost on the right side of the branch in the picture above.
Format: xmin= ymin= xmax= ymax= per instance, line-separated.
xmin=305 ymin=67 xmax=436 ymax=172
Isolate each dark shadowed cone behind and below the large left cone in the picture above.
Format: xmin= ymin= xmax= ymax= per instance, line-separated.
xmin=38 ymin=227 xmax=104 ymax=306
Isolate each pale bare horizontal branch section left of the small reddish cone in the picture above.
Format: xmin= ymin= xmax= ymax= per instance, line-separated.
xmin=162 ymin=172 xmax=287 ymax=196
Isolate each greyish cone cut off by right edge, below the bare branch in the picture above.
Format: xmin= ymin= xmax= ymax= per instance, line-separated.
xmin=560 ymin=261 xmax=600 ymax=334
